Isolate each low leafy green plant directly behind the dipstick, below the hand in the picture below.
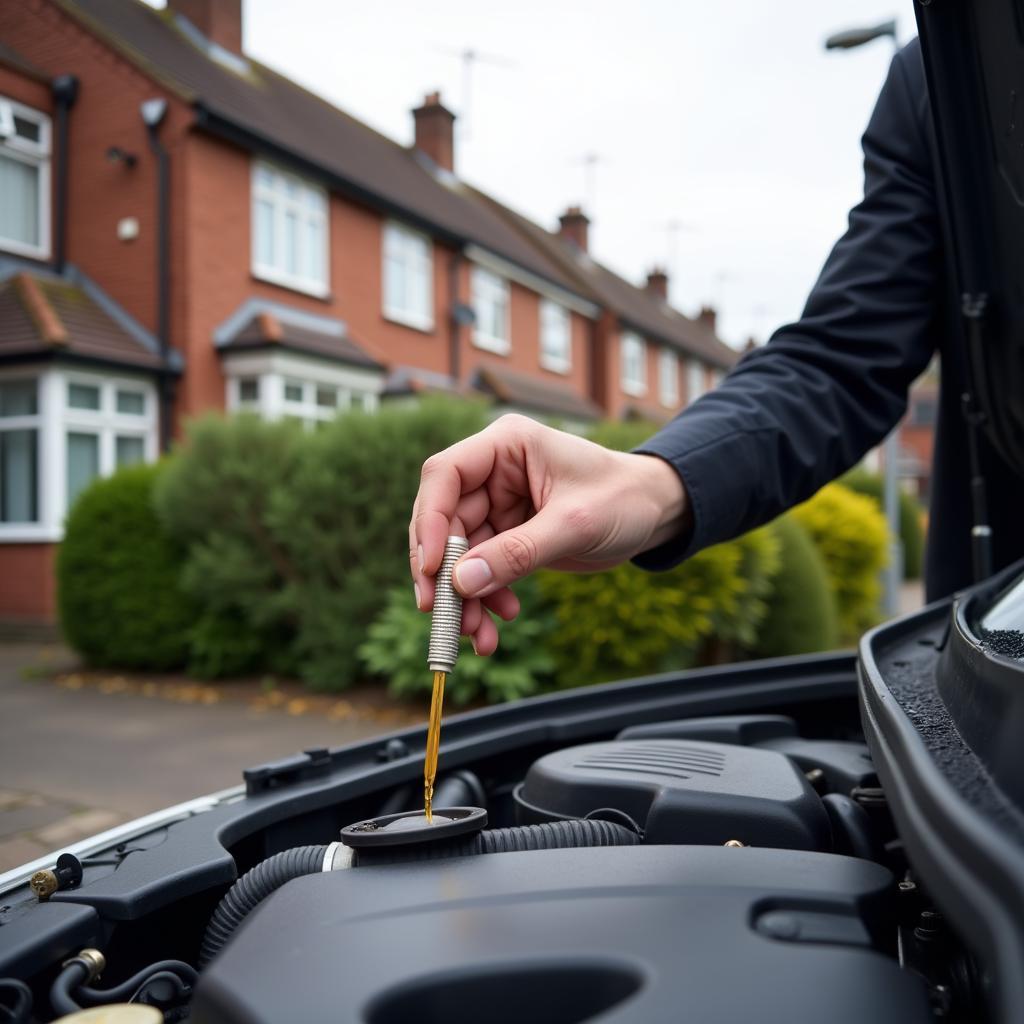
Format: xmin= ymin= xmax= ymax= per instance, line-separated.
xmin=359 ymin=579 xmax=554 ymax=705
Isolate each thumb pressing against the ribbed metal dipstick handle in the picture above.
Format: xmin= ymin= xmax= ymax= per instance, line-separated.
xmin=454 ymin=505 xmax=580 ymax=597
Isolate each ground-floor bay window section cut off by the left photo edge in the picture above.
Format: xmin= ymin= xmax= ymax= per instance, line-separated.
xmin=0 ymin=378 xmax=40 ymax=523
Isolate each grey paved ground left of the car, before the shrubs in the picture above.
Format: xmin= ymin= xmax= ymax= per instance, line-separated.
xmin=0 ymin=643 xmax=409 ymax=872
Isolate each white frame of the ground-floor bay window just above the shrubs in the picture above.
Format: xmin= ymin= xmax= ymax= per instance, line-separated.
xmin=224 ymin=352 xmax=384 ymax=429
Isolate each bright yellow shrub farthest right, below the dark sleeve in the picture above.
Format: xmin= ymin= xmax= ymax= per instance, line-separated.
xmin=792 ymin=483 xmax=889 ymax=643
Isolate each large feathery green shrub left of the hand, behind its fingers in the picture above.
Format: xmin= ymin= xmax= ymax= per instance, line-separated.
xmin=157 ymin=399 xmax=486 ymax=689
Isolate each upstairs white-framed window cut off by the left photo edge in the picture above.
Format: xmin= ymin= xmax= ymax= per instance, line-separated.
xmin=0 ymin=96 xmax=50 ymax=258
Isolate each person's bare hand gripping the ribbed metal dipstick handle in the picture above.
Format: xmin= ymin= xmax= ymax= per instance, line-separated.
xmin=409 ymin=415 xmax=688 ymax=654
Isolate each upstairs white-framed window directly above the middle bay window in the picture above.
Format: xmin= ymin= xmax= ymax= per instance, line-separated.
xmin=252 ymin=163 xmax=328 ymax=296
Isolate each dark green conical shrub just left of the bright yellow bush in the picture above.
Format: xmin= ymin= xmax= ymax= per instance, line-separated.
xmin=751 ymin=516 xmax=839 ymax=657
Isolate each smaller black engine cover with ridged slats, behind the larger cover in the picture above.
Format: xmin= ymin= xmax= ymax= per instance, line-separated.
xmin=515 ymin=739 xmax=831 ymax=850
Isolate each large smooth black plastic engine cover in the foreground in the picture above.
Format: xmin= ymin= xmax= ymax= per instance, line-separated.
xmin=191 ymin=846 xmax=932 ymax=1024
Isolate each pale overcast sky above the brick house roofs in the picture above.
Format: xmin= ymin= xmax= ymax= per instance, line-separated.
xmin=156 ymin=0 xmax=914 ymax=345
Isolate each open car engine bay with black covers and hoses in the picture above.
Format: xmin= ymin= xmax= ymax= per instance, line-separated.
xmin=0 ymin=613 xmax=1012 ymax=1024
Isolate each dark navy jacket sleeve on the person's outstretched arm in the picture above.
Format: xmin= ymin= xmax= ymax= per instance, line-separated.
xmin=635 ymin=41 xmax=941 ymax=569
